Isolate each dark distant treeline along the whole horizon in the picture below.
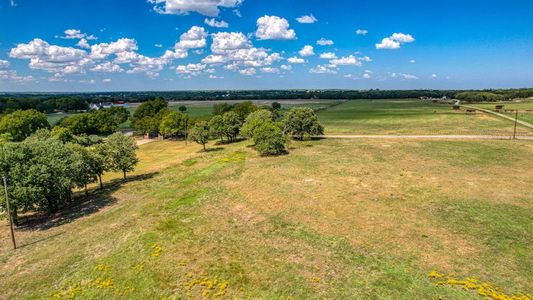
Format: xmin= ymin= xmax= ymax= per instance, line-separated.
xmin=0 ymin=88 xmax=533 ymax=113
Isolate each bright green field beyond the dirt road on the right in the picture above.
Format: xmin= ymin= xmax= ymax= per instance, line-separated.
xmin=319 ymin=100 xmax=531 ymax=135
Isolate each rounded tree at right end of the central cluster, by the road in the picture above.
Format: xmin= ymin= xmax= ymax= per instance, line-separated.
xmin=283 ymin=107 xmax=324 ymax=140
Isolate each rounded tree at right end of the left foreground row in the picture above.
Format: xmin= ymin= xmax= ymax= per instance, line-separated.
xmin=102 ymin=133 xmax=139 ymax=179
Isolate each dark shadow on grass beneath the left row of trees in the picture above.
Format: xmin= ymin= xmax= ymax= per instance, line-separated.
xmin=17 ymin=172 xmax=158 ymax=231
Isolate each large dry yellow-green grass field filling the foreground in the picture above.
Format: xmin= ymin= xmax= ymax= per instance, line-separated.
xmin=0 ymin=140 xmax=533 ymax=299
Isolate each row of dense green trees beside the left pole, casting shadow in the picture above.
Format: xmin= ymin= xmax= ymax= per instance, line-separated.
xmin=0 ymin=129 xmax=138 ymax=222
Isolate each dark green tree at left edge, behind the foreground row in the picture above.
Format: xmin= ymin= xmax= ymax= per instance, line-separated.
xmin=0 ymin=109 xmax=50 ymax=142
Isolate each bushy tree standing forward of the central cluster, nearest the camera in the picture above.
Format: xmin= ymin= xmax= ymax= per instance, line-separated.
xmin=253 ymin=122 xmax=287 ymax=155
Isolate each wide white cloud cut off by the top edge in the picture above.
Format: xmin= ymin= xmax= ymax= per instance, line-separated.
xmin=148 ymin=0 xmax=244 ymax=17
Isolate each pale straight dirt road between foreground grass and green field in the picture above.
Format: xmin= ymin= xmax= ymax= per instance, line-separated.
xmin=320 ymin=135 xmax=533 ymax=140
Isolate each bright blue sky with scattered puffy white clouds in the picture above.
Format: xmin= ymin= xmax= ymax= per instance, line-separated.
xmin=0 ymin=0 xmax=533 ymax=91
